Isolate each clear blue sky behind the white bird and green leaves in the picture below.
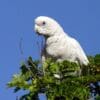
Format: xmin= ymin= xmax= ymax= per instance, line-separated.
xmin=0 ymin=0 xmax=100 ymax=100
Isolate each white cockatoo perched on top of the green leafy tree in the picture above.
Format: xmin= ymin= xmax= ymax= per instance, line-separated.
xmin=35 ymin=16 xmax=89 ymax=65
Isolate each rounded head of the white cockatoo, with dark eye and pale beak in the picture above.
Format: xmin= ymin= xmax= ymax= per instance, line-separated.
xmin=34 ymin=16 xmax=63 ymax=36
